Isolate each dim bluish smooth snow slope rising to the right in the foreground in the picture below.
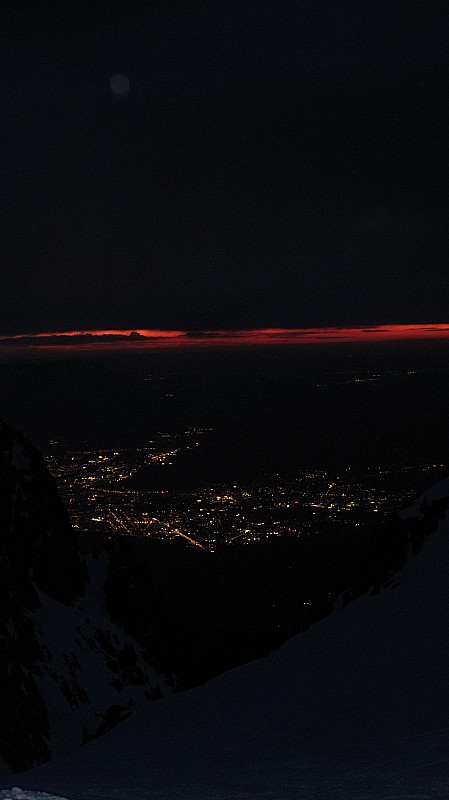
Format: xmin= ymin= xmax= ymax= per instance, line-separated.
xmin=4 ymin=480 xmax=449 ymax=800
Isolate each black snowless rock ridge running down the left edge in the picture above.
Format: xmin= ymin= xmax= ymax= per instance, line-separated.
xmin=0 ymin=425 xmax=86 ymax=768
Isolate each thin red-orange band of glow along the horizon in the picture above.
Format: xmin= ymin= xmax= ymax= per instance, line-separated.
xmin=0 ymin=323 xmax=449 ymax=351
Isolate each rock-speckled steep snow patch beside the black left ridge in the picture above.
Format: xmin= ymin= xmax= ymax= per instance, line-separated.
xmin=30 ymin=557 xmax=167 ymax=755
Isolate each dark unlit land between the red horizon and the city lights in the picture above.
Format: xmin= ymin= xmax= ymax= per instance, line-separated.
xmin=0 ymin=350 xmax=449 ymax=478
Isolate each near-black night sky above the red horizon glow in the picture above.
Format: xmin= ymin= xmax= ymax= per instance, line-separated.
xmin=0 ymin=0 xmax=449 ymax=335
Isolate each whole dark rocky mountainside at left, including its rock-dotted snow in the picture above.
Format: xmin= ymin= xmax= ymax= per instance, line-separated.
xmin=0 ymin=426 xmax=166 ymax=771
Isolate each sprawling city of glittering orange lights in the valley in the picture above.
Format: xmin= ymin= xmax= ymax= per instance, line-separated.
xmin=46 ymin=427 xmax=446 ymax=551
